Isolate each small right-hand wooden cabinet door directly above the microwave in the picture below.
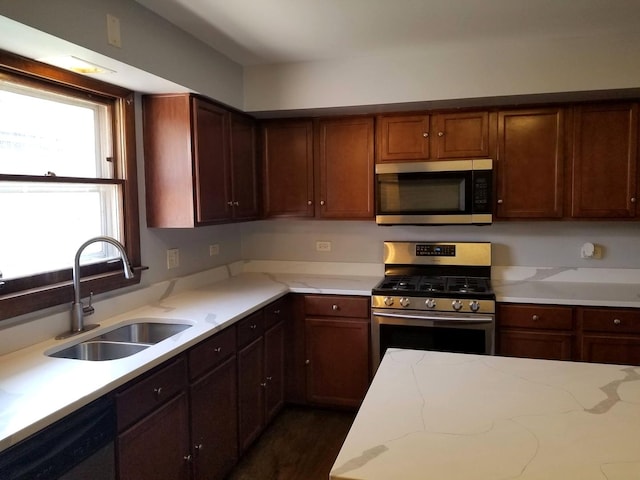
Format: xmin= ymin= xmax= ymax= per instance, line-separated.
xmin=432 ymin=112 xmax=489 ymax=159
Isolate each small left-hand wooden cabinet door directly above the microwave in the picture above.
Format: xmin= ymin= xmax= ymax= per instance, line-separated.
xmin=376 ymin=115 xmax=431 ymax=162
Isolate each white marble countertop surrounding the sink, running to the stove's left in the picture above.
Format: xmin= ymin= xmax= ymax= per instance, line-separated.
xmin=0 ymin=270 xmax=380 ymax=451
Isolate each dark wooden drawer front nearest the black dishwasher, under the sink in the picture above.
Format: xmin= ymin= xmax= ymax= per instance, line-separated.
xmin=116 ymin=356 xmax=187 ymax=431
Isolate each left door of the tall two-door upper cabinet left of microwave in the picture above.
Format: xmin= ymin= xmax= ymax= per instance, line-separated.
xmin=262 ymin=121 xmax=314 ymax=217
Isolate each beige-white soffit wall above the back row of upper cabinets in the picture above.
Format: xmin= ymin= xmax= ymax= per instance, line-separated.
xmin=244 ymin=32 xmax=640 ymax=112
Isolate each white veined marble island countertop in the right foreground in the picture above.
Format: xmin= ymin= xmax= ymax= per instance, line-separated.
xmin=330 ymin=350 xmax=640 ymax=480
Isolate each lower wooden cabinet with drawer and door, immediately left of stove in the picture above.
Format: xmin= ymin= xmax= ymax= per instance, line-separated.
xmin=304 ymin=295 xmax=370 ymax=407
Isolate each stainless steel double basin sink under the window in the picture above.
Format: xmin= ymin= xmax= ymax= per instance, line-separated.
xmin=47 ymin=318 xmax=191 ymax=361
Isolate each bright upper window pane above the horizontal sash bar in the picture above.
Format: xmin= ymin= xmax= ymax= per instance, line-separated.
xmin=0 ymin=82 xmax=113 ymax=178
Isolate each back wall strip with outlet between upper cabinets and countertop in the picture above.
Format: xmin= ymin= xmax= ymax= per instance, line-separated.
xmin=242 ymin=220 xmax=640 ymax=268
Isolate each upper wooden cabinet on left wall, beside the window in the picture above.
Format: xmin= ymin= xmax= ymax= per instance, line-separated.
xmin=143 ymin=95 xmax=259 ymax=227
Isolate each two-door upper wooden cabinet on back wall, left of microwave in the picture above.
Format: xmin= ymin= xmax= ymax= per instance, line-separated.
xmin=262 ymin=116 xmax=374 ymax=219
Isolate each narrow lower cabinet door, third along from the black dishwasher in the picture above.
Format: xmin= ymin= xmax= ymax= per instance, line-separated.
xmin=238 ymin=337 xmax=265 ymax=452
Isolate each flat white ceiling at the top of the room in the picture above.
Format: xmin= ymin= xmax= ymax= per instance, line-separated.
xmin=136 ymin=0 xmax=640 ymax=65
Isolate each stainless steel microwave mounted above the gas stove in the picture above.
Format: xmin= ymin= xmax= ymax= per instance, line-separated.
xmin=375 ymin=159 xmax=493 ymax=225
